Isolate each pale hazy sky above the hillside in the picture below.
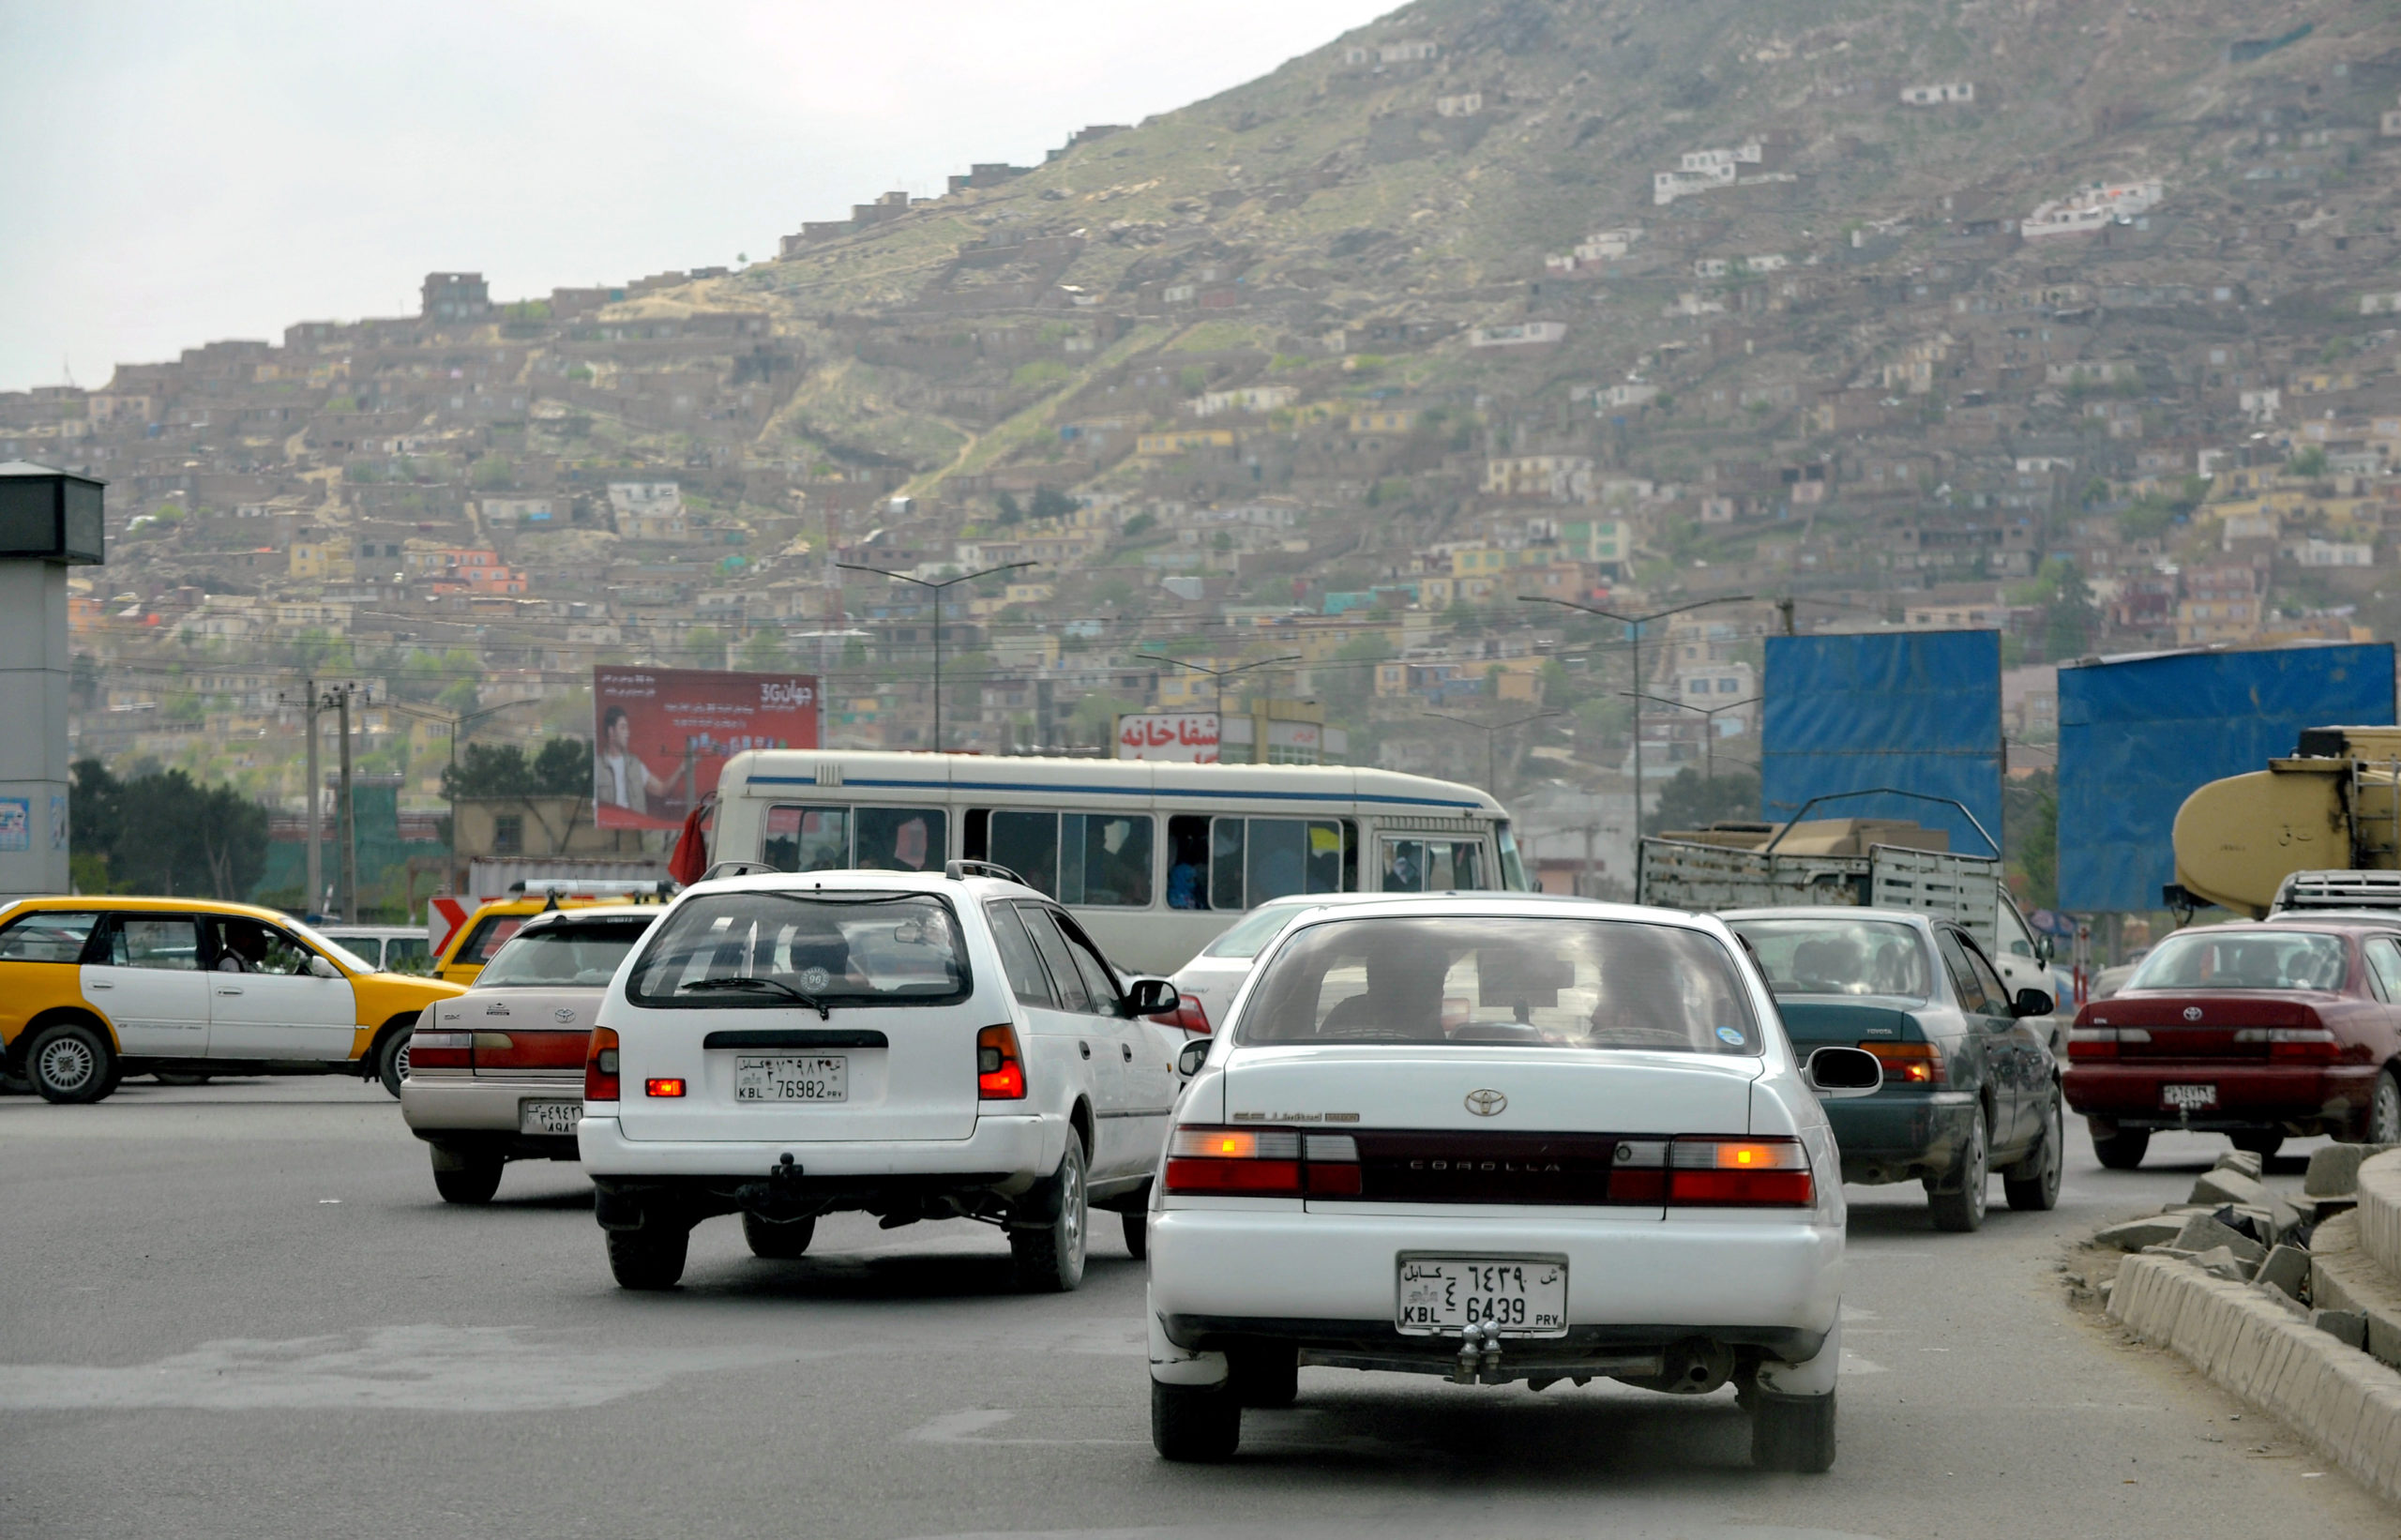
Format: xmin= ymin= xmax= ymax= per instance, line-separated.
xmin=0 ymin=0 xmax=1395 ymax=389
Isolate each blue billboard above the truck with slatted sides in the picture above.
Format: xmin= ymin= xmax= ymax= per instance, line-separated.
xmin=1759 ymin=632 xmax=2002 ymax=855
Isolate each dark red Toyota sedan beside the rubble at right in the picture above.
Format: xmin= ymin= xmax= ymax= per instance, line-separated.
xmin=2065 ymin=915 xmax=2401 ymax=1170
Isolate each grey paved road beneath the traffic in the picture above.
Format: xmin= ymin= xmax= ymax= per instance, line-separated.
xmin=0 ymin=1081 xmax=2396 ymax=1540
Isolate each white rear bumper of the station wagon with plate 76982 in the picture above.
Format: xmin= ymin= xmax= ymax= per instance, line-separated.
xmin=576 ymin=1108 xmax=1068 ymax=1197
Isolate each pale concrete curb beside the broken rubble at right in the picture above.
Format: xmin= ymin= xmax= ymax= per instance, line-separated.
xmin=2108 ymin=1257 xmax=2401 ymax=1502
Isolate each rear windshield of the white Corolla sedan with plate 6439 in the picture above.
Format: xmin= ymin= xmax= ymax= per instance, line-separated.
xmin=1234 ymin=915 xmax=1759 ymax=1052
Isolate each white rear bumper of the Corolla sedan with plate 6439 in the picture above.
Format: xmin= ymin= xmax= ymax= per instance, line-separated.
xmin=1150 ymin=1208 xmax=1842 ymax=1336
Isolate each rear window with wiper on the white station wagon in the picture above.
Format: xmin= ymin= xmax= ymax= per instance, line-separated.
xmin=627 ymin=889 xmax=970 ymax=1009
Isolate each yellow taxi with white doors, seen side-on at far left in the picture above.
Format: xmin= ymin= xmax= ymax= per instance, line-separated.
xmin=0 ymin=896 xmax=463 ymax=1103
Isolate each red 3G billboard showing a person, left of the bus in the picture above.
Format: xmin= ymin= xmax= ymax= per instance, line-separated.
xmin=593 ymin=666 xmax=822 ymax=829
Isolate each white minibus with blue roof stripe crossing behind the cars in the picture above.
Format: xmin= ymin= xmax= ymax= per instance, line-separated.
xmin=708 ymin=749 xmax=1527 ymax=973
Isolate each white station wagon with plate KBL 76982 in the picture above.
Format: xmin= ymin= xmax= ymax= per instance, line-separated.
xmin=576 ymin=863 xmax=1184 ymax=1291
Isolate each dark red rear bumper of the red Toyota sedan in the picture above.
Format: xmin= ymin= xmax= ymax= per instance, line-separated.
xmin=2060 ymin=1060 xmax=2377 ymax=1137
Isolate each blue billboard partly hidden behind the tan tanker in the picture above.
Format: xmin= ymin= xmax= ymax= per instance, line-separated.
xmin=2060 ymin=642 xmax=2393 ymax=913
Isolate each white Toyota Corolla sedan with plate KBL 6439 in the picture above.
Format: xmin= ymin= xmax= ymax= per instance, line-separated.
xmin=1148 ymin=894 xmax=1882 ymax=1471
